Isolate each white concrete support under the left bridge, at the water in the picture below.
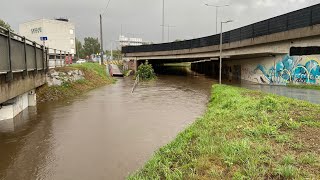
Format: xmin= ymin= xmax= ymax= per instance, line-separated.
xmin=0 ymin=90 xmax=37 ymax=121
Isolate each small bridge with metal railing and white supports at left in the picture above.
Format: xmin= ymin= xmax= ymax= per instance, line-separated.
xmin=0 ymin=27 xmax=71 ymax=121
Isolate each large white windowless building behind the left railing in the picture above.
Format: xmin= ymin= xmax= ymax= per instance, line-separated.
xmin=19 ymin=18 xmax=76 ymax=56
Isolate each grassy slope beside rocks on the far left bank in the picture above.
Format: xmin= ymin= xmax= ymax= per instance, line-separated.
xmin=37 ymin=63 xmax=113 ymax=102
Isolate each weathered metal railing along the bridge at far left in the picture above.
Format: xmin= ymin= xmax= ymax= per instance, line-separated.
xmin=0 ymin=27 xmax=70 ymax=81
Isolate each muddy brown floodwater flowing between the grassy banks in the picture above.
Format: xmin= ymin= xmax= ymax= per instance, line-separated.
xmin=0 ymin=68 xmax=214 ymax=180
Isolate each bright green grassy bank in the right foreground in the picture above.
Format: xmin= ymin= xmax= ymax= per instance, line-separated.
xmin=128 ymin=85 xmax=320 ymax=180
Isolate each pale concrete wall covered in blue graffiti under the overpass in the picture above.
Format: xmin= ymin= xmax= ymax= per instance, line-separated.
xmin=223 ymin=54 xmax=320 ymax=85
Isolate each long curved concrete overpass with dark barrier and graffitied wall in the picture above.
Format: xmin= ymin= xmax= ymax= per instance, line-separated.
xmin=122 ymin=4 xmax=320 ymax=84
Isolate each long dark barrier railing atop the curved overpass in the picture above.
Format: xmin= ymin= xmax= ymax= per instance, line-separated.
xmin=122 ymin=4 xmax=320 ymax=53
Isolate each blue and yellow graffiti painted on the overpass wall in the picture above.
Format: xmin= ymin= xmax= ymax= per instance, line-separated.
xmin=254 ymin=55 xmax=320 ymax=84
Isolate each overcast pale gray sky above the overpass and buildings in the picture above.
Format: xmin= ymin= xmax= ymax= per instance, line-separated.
xmin=0 ymin=0 xmax=320 ymax=49
